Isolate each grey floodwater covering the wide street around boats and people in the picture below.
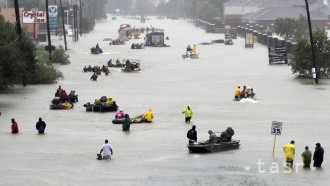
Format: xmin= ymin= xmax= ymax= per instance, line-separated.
xmin=0 ymin=17 xmax=330 ymax=185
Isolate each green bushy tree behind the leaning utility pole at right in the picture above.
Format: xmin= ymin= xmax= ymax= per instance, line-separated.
xmin=289 ymin=29 xmax=330 ymax=78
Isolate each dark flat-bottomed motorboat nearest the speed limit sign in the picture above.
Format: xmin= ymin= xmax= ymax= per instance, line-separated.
xmin=187 ymin=127 xmax=240 ymax=153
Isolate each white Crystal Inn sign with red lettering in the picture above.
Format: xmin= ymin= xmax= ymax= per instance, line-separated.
xmin=22 ymin=9 xmax=47 ymax=24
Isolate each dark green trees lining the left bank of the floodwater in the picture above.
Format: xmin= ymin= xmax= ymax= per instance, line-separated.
xmin=0 ymin=16 xmax=70 ymax=89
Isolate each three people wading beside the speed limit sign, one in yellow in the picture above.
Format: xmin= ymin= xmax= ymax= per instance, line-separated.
xmin=283 ymin=140 xmax=324 ymax=168
